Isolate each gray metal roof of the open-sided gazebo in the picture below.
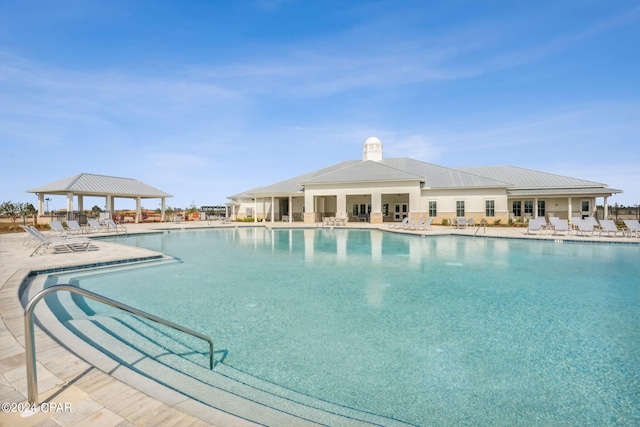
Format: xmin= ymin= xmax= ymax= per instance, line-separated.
xmin=27 ymin=173 xmax=173 ymax=198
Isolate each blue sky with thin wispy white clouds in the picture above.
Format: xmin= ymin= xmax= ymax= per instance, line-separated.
xmin=0 ymin=0 xmax=640 ymax=209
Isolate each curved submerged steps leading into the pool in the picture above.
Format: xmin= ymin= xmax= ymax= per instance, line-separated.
xmin=48 ymin=292 xmax=416 ymax=427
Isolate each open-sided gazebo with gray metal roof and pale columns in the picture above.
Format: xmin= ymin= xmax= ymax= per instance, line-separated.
xmin=27 ymin=173 xmax=173 ymax=223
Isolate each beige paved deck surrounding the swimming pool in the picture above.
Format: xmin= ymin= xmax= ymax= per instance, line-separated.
xmin=0 ymin=221 xmax=640 ymax=426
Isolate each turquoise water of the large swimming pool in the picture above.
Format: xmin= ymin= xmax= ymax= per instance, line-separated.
xmin=46 ymin=228 xmax=640 ymax=426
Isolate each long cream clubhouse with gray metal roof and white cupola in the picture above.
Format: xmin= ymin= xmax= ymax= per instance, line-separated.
xmin=227 ymin=137 xmax=622 ymax=224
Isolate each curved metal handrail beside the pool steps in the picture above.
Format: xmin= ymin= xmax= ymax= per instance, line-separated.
xmin=24 ymin=284 xmax=213 ymax=405
